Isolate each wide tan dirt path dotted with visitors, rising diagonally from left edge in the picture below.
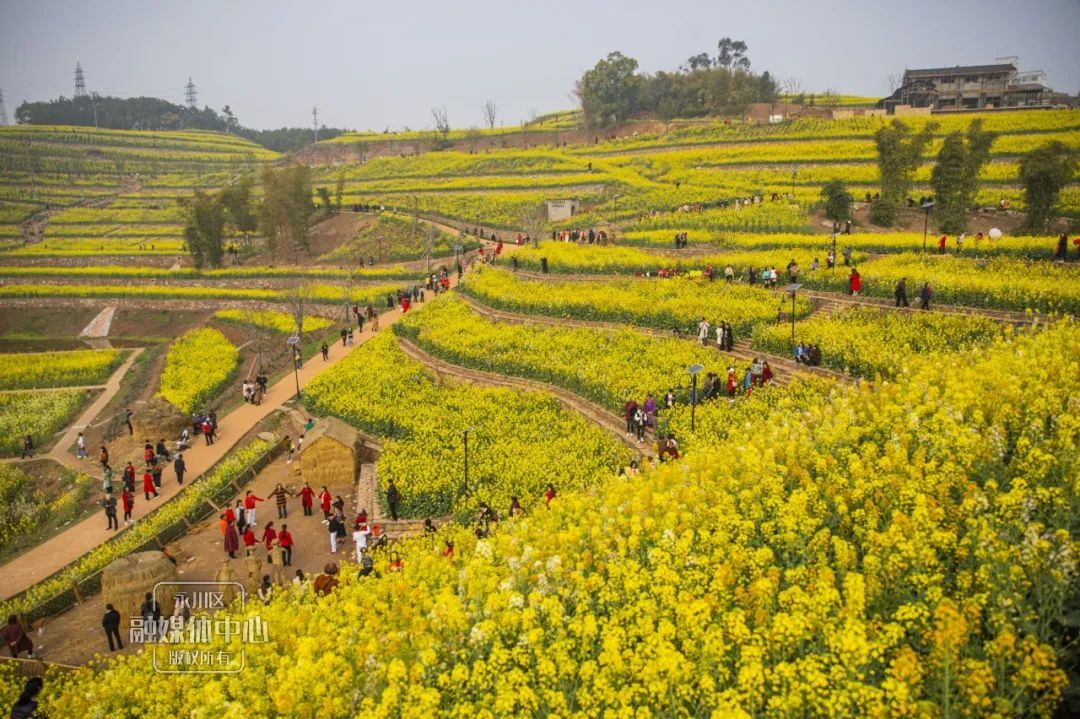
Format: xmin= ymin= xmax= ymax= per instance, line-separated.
xmin=0 ymin=258 xmax=483 ymax=599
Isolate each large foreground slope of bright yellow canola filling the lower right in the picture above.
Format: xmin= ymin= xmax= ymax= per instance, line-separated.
xmin=10 ymin=324 xmax=1080 ymax=719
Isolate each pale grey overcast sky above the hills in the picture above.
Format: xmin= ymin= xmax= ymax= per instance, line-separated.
xmin=0 ymin=0 xmax=1080 ymax=130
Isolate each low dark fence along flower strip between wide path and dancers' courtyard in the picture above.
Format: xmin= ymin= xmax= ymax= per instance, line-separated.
xmin=8 ymin=439 xmax=285 ymax=628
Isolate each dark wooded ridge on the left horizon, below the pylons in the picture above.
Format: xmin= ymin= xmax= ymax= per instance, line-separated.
xmin=15 ymin=95 xmax=347 ymax=152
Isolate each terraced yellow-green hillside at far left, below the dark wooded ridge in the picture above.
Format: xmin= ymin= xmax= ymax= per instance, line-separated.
xmin=0 ymin=125 xmax=279 ymax=258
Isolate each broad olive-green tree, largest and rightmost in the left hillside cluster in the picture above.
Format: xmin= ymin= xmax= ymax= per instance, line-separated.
xmin=259 ymin=165 xmax=312 ymax=261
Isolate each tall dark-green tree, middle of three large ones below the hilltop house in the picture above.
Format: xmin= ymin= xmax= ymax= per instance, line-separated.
xmin=930 ymin=120 xmax=995 ymax=233
